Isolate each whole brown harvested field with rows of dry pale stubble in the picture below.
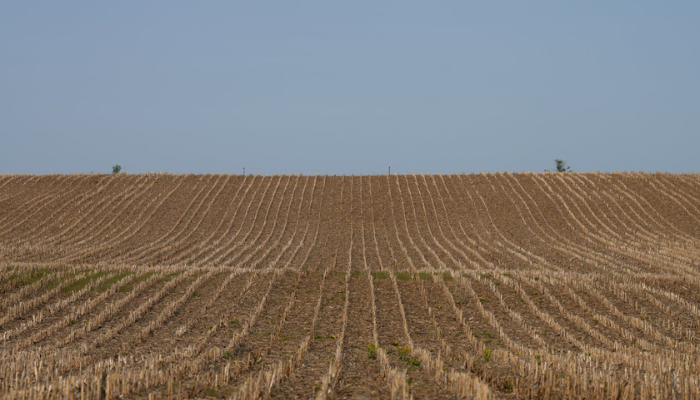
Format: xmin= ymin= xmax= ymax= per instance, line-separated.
xmin=0 ymin=173 xmax=700 ymax=399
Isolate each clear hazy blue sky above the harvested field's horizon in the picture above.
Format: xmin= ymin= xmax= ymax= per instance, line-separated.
xmin=0 ymin=0 xmax=700 ymax=174
